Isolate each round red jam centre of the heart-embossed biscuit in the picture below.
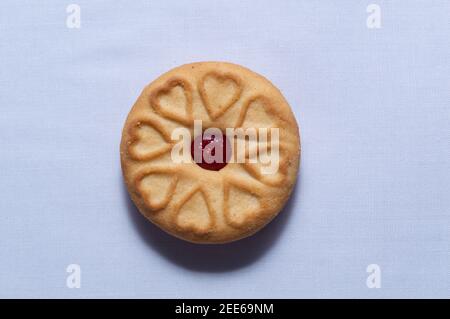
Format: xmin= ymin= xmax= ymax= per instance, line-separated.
xmin=191 ymin=134 xmax=231 ymax=171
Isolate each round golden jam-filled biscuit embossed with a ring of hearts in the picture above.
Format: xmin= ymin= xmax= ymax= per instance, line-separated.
xmin=120 ymin=62 xmax=300 ymax=243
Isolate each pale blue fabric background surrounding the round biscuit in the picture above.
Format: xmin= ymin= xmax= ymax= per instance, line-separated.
xmin=0 ymin=0 xmax=450 ymax=298
